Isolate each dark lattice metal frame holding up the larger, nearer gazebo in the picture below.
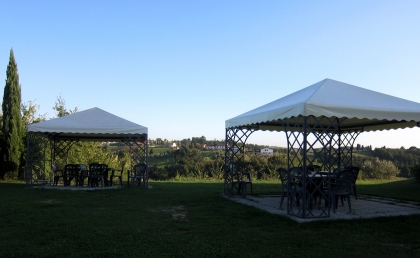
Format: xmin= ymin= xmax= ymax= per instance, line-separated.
xmin=224 ymin=116 xmax=362 ymax=218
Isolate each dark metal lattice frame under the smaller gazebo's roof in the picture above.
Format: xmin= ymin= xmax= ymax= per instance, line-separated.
xmin=25 ymin=132 xmax=149 ymax=187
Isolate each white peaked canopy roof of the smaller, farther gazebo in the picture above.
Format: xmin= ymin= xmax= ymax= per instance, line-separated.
xmin=28 ymin=107 xmax=147 ymax=141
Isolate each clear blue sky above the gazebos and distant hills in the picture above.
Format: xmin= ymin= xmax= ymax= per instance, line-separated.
xmin=0 ymin=0 xmax=420 ymax=148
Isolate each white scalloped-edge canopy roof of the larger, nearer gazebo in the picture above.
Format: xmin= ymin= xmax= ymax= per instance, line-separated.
xmin=225 ymin=79 xmax=420 ymax=131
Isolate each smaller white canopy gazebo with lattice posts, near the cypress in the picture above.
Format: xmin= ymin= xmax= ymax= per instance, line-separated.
xmin=25 ymin=107 xmax=148 ymax=185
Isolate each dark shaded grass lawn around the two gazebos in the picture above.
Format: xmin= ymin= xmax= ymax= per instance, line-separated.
xmin=0 ymin=180 xmax=420 ymax=257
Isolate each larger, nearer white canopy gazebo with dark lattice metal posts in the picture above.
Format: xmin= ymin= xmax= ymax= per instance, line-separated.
xmin=225 ymin=79 xmax=420 ymax=217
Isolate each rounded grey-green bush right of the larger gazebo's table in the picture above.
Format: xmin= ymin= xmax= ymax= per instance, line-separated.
xmin=360 ymin=158 xmax=400 ymax=179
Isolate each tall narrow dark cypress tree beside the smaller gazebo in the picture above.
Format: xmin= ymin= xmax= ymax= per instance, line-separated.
xmin=2 ymin=49 xmax=23 ymax=177
